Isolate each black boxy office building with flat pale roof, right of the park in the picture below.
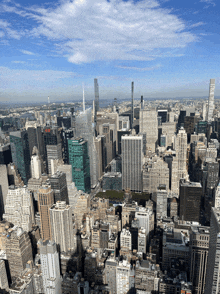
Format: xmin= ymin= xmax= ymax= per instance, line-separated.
xmin=179 ymin=181 xmax=202 ymax=222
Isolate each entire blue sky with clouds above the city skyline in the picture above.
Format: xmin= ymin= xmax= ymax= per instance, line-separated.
xmin=0 ymin=0 xmax=220 ymax=103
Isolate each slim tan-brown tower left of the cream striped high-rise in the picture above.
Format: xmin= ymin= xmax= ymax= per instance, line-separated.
xmin=38 ymin=185 xmax=54 ymax=240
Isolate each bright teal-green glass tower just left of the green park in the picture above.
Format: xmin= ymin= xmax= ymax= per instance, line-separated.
xmin=68 ymin=138 xmax=91 ymax=192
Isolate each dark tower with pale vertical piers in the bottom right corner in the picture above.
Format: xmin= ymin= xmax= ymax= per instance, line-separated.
xmin=190 ymin=226 xmax=210 ymax=294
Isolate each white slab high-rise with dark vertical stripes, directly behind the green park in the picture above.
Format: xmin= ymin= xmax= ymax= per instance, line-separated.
xmin=121 ymin=135 xmax=144 ymax=192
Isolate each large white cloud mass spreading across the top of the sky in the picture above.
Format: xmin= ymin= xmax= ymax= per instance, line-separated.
xmin=3 ymin=0 xmax=197 ymax=64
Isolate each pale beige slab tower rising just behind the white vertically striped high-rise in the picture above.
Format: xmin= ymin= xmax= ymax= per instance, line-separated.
xmin=139 ymin=109 xmax=158 ymax=154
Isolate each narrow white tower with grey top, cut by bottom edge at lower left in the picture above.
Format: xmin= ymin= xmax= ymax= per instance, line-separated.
xmin=39 ymin=240 xmax=62 ymax=294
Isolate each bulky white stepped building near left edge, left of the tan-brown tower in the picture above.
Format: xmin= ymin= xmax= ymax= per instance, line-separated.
xmin=3 ymin=186 xmax=35 ymax=232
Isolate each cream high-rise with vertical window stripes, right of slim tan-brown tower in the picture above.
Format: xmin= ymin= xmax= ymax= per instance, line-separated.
xmin=50 ymin=201 xmax=76 ymax=252
